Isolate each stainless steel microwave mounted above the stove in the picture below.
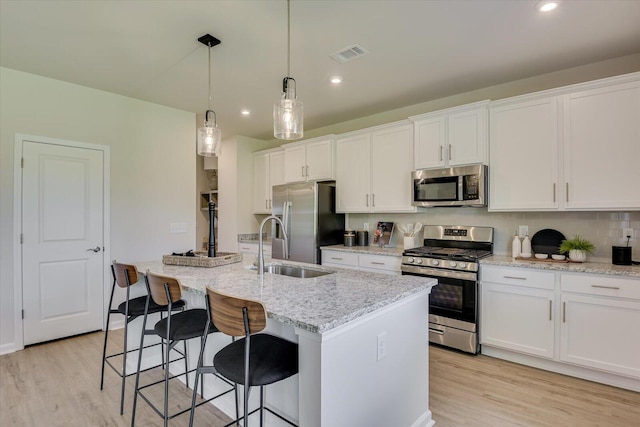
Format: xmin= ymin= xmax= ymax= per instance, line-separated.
xmin=411 ymin=164 xmax=488 ymax=207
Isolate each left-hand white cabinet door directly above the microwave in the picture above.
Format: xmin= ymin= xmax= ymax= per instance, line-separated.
xmin=414 ymin=115 xmax=447 ymax=169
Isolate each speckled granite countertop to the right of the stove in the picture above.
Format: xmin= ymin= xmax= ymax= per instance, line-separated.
xmin=480 ymin=255 xmax=640 ymax=278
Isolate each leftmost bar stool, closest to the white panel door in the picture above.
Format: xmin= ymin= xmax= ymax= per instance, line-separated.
xmin=100 ymin=260 xmax=184 ymax=415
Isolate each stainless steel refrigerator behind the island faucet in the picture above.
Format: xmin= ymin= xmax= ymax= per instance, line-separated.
xmin=271 ymin=181 xmax=344 ymax=264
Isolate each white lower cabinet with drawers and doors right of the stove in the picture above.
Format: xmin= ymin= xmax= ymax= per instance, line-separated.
xmin=479 ymin=265 xmax=640 ymax=391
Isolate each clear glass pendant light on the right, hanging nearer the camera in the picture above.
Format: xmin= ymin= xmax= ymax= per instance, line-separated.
xmin=273 ymin=0 xmax=304 ymax=140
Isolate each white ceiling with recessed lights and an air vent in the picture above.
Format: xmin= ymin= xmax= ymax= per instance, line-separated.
xmin=0 ymin=0 xmax=640 ymax=139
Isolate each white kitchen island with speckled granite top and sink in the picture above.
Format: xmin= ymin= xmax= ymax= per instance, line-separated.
xmin=132 ymin=262 xmax=436 ymax=427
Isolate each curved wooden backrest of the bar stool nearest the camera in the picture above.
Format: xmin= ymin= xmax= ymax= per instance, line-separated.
xmin=207 ymin=288 xmax=267 ymax=337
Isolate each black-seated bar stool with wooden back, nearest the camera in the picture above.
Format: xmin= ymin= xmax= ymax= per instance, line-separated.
xmin=189 ymin=288 xmax=298 ymax=427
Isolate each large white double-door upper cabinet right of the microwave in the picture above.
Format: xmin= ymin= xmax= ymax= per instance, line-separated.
xmin=489 ymin=73 xmax=640 ymax=211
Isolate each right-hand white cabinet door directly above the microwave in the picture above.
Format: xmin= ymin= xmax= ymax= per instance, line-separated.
xmin=445 ymin=107 xmax=487 ymax=166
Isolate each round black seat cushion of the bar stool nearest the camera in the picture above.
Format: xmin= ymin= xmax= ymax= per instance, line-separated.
xmin=213 ymin=334 xmax=298 ymax=386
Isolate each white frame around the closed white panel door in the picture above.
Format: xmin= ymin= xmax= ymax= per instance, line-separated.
xmin=13 ymin=133 xmax=111 ymax=351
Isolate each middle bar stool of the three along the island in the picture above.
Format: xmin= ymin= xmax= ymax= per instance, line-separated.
xmin=131 ymin=271 xmax=233 ymax=427
